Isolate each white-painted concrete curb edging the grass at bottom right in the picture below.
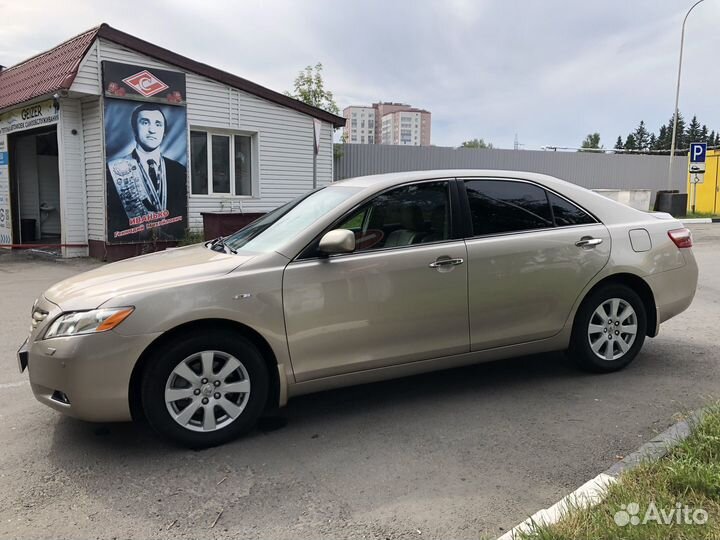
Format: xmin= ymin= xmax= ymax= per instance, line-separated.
xmin=497 ymin=409 xmax=706 ymax=540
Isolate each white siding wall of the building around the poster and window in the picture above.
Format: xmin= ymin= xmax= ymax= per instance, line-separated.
xmin=70 ymin=39 xmax=333 ymax=232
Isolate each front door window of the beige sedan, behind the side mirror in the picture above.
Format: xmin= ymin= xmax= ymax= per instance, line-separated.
xmin=337 ymin=182 xmax=450 ymax=252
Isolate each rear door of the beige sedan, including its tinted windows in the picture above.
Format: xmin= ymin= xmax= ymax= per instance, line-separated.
xmin=460 ymin=178 xmax=610 ymax=351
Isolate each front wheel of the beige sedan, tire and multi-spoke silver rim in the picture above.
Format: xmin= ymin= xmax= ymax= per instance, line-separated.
xmin=141 ymin=331 xmax=269 ymax=449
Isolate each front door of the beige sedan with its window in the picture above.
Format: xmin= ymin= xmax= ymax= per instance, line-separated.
xmin=283 ymin=181 xmax=469 ymax=381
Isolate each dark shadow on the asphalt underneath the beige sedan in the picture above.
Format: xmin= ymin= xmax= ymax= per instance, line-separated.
xmin=46 ymin=353 xmax=597 ymax=456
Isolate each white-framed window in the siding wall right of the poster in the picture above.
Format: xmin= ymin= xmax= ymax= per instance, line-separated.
xmin=190 ymin=130 xmax=253 ymax=197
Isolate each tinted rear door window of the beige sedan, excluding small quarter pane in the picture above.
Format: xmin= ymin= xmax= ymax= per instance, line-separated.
xmin=465 ymin=180 xmax=553 ymax=236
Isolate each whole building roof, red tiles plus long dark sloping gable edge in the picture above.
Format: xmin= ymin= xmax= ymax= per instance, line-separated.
xmin=0 ymin=23 xmax=345 ymax=127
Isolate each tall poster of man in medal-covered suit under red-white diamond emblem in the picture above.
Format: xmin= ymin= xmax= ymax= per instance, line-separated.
xmin=103 ymin=61 xmax=188 ymax=243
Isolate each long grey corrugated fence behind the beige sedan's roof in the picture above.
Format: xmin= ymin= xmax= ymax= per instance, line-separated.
xmin=335 ymin=144 xmax=687 ymax=200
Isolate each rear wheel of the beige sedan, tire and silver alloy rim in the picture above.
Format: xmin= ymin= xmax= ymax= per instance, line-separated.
xmin=568 ymin=284 xmax=647 ymax=373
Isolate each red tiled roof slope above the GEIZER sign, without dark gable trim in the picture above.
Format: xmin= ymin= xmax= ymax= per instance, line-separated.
xmin=0 ymin=27 xmax=100 ymax=110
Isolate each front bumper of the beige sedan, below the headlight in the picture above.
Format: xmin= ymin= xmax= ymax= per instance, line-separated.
xmin=26 ymin=330 xmax=160 ymax=422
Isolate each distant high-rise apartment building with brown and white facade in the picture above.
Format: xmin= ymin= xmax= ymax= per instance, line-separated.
xmin=343 ymin=102 xmax=431 ymax=146
